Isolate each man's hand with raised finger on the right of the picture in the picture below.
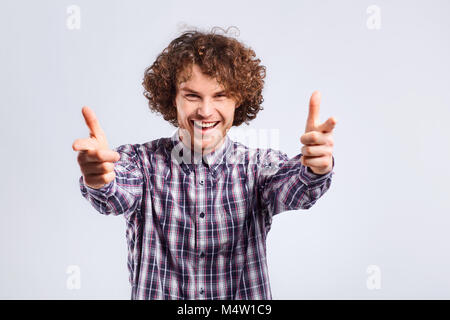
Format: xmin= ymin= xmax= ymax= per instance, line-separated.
xmin=300 ymin=91 xmax=337 ymax=174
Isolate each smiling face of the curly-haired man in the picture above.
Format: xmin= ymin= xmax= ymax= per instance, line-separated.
xmin=175 ymin=65 xmax=236 ymax=154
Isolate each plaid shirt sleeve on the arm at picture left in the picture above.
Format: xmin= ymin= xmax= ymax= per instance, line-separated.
xmin=79 ymin=144 xmax=144 ymax=218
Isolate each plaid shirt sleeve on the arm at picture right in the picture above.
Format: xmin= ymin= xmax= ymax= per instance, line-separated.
xmin=257 ymin=149 xmax=334 ymax=223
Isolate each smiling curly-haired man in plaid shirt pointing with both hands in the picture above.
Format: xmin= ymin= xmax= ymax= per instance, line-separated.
xmin=72 ymin=31 xmax=336 ymax=299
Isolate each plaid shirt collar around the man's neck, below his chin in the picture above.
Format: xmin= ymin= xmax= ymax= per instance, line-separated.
xmin=170 ymin=129 xmax=232 ymax=174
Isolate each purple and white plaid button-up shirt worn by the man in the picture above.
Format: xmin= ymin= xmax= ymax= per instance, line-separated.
xmin=79 ymin=130 xmax=334 ymax=299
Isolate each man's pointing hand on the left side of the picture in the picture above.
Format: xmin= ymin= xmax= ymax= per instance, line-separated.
xmin=72 ymin=107 xmax=120 ymax=189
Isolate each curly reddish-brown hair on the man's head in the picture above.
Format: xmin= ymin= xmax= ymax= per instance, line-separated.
xmin=142 ymin=27 xmax=266 ymax=127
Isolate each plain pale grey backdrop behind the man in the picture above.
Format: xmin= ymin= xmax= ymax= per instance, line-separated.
xmin=0 ymin=0 xmax=450 ymax=299
